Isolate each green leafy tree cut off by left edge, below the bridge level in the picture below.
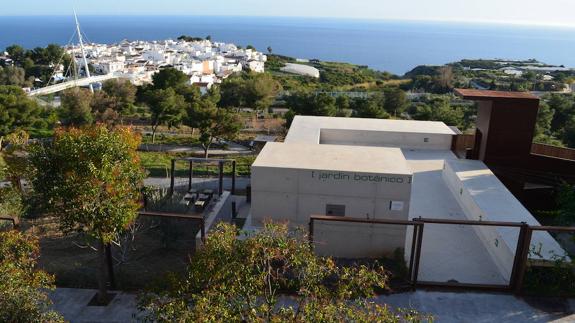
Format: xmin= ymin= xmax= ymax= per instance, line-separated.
xmin=0 ymin=86 xmax=42 ymax=137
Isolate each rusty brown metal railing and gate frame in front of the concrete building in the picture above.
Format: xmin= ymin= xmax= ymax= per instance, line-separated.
xmin=308 ymin=215 xmax=575 ymax=294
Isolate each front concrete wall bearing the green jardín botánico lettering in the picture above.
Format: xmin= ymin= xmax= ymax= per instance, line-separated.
xmin=251 ymin=166 xmax=412 ymax=257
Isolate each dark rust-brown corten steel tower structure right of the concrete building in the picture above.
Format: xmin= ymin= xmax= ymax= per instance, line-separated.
xmin=455 ymin=89 xmax=575 ymax=187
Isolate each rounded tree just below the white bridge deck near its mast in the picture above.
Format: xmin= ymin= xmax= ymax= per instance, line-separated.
xmin=60 ymin=88 xmax=94 ymax=126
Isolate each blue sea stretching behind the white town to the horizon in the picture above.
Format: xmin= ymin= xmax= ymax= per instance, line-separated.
xmin=0 ymin=15 xmax=575 ymax=75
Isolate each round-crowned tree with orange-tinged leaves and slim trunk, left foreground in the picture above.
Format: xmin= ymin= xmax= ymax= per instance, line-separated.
xmin=30 ymin=125 xmax=144 ymax=303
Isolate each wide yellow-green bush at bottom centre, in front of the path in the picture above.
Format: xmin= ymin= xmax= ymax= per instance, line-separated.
xmin=139 ymin=223 xmax=422 ymax=322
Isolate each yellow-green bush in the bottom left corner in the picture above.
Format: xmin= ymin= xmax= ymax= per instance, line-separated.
xmin=0 ymin=231 xmax=64 ymax=323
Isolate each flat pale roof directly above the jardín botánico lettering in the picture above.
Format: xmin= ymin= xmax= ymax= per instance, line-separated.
xmin=252 ymin=142 xmax=412 ymax=175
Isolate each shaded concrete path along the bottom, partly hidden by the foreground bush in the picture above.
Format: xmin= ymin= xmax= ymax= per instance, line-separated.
xmin=50 ymin=288 xmax=575 ymax=323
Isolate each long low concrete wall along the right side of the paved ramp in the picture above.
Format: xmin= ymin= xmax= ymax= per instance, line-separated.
xmin=443 ymin=160 xmax=566 ymax=279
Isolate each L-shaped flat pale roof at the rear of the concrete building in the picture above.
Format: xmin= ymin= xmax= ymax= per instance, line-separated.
xmin=285 ymin=116 xmax=457 ymax=144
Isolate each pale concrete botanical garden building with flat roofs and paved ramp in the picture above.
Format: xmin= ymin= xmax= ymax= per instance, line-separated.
xmin=248 ymin=114 xmax=566 ymax=284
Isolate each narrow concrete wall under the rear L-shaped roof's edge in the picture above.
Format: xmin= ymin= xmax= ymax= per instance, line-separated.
xmin=319 ymin=129 xmax=453 ymax=150
